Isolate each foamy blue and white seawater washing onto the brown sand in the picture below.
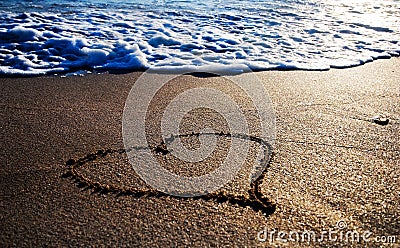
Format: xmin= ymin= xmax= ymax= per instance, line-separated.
xmin=0 ymin=0 xmax=400 ymax=75
